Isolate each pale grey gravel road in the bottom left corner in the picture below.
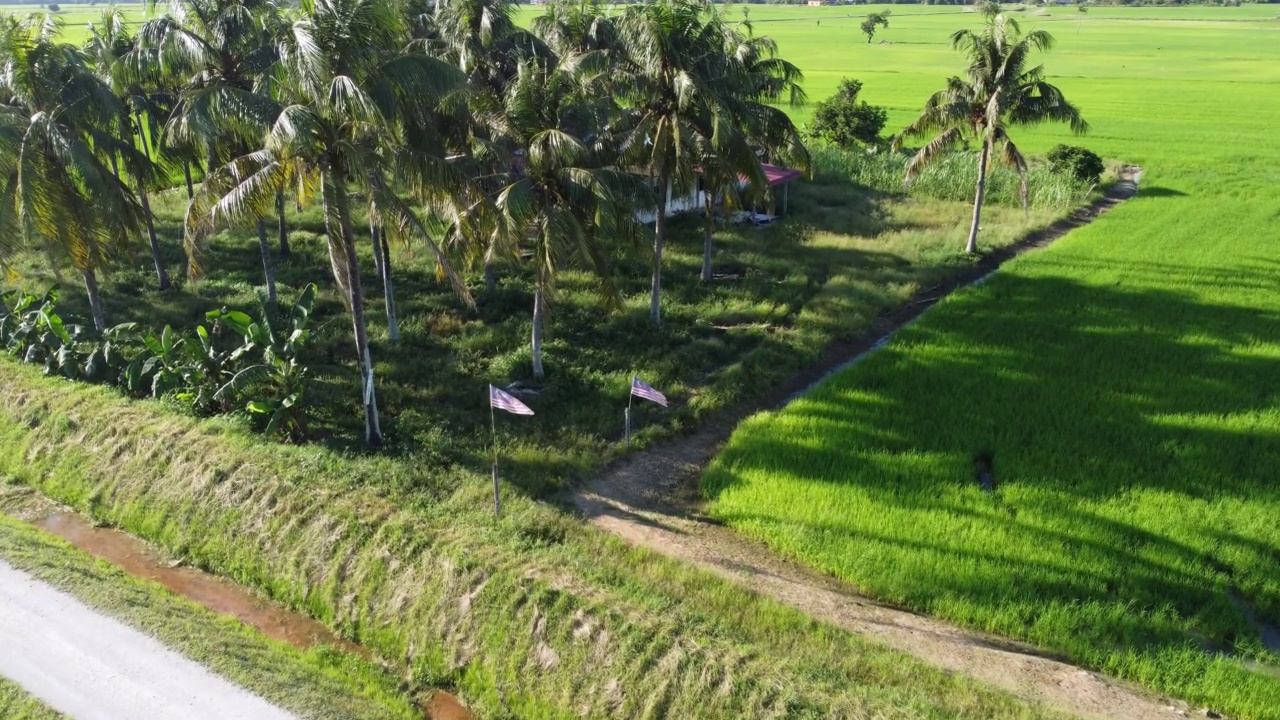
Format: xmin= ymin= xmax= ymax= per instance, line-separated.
xmin=0 ymin=560 xmax=294 ymax=720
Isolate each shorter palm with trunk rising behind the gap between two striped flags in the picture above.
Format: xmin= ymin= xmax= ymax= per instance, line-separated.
xmin=494 ymin=57 xmax=648 ymax=378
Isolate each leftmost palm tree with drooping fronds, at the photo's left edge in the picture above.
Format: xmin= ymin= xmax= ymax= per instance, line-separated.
xmin=0 ymin=15 xmax=146 ymax=331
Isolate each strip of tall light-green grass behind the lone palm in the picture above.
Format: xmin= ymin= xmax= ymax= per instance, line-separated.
xmin=812 ymin=145 xmax=1093 ymax=210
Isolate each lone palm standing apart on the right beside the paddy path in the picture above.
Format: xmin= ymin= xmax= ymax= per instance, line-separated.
xmin=895 ymin=13 xmax=1089 ymax=254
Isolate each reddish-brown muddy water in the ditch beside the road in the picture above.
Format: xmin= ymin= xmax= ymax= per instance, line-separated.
xmin=32 ymin=512 xmax=475 ymax=720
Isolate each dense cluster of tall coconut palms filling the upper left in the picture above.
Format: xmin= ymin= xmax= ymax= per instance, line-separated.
xmin=0 ymin=0 xmax=808 ymax=446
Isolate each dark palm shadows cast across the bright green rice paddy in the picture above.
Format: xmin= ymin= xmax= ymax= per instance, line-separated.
xmin=704 ymin=269 xmax=1280 ymax=657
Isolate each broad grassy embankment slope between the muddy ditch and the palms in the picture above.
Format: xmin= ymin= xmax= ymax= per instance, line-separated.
xmin=0 ymin=365 xmax=1057 ymax=720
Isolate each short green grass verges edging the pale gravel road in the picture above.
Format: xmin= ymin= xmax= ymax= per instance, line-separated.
xmin=0 ymin=499 xmax=421 ymax=720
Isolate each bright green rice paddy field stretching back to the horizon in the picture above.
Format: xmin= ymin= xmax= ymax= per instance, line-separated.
xmin=704 ymin=5 xmax=1280 ymax=717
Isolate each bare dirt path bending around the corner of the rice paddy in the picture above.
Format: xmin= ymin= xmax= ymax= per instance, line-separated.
xmin=570 ymin=167 xmax=1189 ymax=720
